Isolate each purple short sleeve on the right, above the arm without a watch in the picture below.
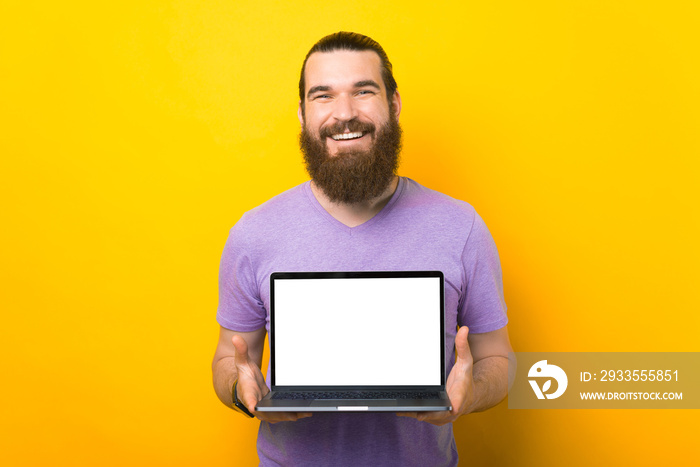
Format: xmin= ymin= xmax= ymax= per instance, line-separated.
xmin=458 ymin=213 xmax=508 ymax=334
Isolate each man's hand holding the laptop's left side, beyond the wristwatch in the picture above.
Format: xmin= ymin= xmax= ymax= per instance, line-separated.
xmin=231 ymin=336 xmax=311 ymax=423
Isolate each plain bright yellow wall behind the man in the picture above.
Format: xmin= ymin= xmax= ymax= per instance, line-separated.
xmin=0 ymin=0 xmax=700 ymax=466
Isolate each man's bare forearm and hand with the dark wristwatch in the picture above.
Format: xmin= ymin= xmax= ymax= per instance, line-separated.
xmin=212 ymin=327 xmax=311 ymax=423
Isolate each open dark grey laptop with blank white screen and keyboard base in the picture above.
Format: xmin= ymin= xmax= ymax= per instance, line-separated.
xmin=255 ymin=271 xmax=452 ymax=412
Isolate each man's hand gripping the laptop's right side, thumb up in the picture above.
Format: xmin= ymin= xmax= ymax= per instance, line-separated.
xmin=396 ymin=326 xmax=475 ymax=426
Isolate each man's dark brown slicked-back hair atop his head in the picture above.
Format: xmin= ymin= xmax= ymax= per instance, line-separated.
xmin=299 ymin=31 xmax=397 ymax=106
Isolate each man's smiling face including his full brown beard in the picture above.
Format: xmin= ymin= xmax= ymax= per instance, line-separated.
xmin=299 ymin=51 xmax=401 ymax=203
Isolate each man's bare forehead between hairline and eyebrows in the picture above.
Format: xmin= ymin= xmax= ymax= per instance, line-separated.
xmin=304 ymin=50 xmax=384 ymax=90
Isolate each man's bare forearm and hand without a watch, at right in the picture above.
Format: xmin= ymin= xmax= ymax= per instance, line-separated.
xmin=399 ymin=326 xmax=513 ymax=425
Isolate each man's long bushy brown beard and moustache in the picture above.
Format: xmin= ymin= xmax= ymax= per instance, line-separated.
xmin=299 ymin=112 xmax=401 ymax=204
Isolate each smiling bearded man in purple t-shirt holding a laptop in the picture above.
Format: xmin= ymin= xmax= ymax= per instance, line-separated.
xmin=212 ymin=32 xmax=512 ymax=466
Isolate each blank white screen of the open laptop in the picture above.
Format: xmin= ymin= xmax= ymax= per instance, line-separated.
xmin=273 ymin=277 xmax=444 ymax=386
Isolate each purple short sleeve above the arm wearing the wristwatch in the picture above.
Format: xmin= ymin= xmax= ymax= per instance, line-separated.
xmin=216 ymin=221 xmax=267 ymax=332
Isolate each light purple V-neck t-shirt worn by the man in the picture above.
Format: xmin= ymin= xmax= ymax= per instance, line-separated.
xmin=217 ymin=177 xmax=508 ymax=466
